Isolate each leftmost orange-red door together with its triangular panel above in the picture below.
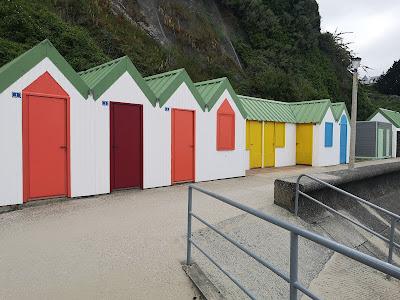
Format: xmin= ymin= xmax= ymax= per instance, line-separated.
xmin=23 ymin=73 xmax=70 ymax=201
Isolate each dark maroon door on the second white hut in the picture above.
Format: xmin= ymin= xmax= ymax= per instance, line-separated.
xmin=110 ymin=102 xmax=143 ymax=190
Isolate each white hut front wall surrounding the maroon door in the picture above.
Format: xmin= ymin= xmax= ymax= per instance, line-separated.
xmin=94 ymin=72 xmax=166 ymax=190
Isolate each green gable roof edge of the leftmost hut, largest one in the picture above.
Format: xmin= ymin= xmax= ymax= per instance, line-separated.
xmin=0 ymin=40 xmax=89 ymax=99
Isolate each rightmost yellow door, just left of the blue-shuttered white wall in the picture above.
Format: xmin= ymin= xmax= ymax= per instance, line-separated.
xmin=296 ymin=124 xmax=313 ymax=165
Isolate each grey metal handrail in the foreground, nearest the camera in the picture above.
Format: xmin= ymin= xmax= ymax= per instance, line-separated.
xmin=186 ymin=185 xmax=400 ymax=300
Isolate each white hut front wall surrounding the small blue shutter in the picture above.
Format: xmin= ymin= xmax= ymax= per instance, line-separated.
xmin=312 ymin=108 xmax=340 ymax=167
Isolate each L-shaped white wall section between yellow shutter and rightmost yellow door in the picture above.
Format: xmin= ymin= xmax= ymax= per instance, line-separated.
xmin=275 ymin=123 xmax=296 ymax=167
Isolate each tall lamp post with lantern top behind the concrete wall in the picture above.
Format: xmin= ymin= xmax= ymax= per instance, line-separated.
xmin=349 ymin=57 xmax=361 ymax=169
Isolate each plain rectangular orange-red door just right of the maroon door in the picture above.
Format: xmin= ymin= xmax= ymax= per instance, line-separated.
xmin=172 ymin=109 xmax=195 ymax=183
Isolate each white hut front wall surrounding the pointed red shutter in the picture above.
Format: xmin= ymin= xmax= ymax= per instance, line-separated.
xmin=196 ymin=90 xmax=246 ymax=181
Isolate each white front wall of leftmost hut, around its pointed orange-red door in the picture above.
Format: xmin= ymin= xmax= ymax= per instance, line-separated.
xmin=0 ymin=58 xmax=96 ymax=206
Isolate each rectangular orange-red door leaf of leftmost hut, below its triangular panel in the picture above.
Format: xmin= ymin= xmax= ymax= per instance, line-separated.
xmin=28 ymin=95 xmax=68 ymax=199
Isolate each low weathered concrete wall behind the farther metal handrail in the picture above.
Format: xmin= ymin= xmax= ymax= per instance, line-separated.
xmin=274 ymin=162 xmax=400 ymax=222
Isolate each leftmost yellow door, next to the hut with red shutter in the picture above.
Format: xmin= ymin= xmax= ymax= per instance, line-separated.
xmin=246 ymin=121 xmax=262 ymax=169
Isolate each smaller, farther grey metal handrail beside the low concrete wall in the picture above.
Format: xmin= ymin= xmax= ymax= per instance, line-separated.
xmin=294 ymin=174 xmax=400 ymax=264
